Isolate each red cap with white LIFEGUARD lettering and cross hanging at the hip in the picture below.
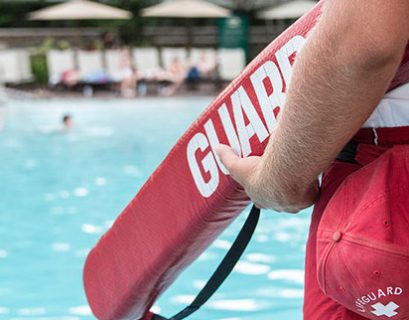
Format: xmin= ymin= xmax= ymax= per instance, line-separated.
xmin=317 ymin=146 xmax=409 ymax=319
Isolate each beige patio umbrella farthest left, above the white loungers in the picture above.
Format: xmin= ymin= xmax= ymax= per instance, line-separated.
xmin=29 ymin=0 xmax=132 ymax=20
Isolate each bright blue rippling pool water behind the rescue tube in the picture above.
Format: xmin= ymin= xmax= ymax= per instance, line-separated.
xmin=0 ymin=98 xmax=310 ymax=320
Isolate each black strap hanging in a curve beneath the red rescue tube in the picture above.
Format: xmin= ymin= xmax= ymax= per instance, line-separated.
xmin=152 ymin=206 xmax=260 ymax=320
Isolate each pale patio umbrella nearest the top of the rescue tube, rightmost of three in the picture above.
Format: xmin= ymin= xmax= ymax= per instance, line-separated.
xmin=257 ymin=0 xmax=317 ymax=20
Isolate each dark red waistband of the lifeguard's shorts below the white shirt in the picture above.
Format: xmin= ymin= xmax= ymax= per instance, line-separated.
xmin=352 ymin=126 xmax=409 ymax=147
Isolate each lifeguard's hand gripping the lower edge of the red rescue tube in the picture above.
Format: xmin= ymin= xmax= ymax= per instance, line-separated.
xmin=217 ymin=145 xmax=318 ymax=213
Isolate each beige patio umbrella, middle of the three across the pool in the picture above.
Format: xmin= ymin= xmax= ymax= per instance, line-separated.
xmin=142 ymin=0 xmax=231 ymax=18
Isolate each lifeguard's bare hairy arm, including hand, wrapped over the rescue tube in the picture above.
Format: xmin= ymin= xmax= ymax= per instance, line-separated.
xmin=220 ymin=0 xmax=409 ymax=211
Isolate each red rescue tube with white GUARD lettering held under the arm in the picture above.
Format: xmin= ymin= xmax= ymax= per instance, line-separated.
xmin=84 ymin=4 xmax=409 ymax=320
